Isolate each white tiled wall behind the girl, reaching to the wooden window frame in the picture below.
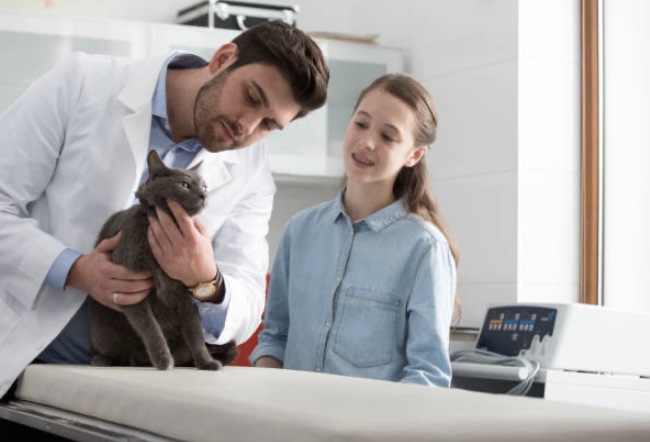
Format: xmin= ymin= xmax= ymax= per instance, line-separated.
xmin=0 ymin=0 xmax=579 ymax=326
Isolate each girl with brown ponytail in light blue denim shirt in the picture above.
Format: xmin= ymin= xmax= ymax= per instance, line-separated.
xmin=250 ymin=75 xmax=457 ymax=387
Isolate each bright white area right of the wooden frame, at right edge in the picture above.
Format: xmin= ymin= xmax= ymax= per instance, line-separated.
xmin=603 ymin=0 xmax=650 ymax=311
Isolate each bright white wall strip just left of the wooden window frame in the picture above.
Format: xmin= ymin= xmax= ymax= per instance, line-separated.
xmin=517 ymin=0 xmax=581 ymax=308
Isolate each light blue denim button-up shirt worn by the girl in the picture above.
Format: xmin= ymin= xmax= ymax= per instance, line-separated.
xmin=250 ymin=189 xmax=456 ymax=387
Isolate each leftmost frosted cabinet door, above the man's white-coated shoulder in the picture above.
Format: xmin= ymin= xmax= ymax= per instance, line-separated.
xmin=0 ymin=13 xmax=147 ymax=112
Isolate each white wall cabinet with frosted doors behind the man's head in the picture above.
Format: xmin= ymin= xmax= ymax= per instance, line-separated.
xmin=0 ymin=13 xmax=403 ymax=181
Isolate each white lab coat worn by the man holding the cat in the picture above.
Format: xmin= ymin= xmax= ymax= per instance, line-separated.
xmin=0 ymin=54 xmax=275 ymax=396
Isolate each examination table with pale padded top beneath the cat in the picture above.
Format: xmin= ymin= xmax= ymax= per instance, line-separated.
xmin=0 ymin=364 xmax=650 ymax=442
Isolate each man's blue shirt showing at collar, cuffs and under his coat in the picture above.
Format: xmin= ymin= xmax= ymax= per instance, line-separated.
xmin=38 ymin=53 xmax=230 ymax=364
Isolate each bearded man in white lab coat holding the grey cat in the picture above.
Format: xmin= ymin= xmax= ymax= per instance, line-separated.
xmin=0 ymin=21 xmax=329 ymax=396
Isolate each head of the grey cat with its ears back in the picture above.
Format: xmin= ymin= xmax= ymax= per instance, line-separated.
xmin=135 ymin=150 xmax=207 ymax=216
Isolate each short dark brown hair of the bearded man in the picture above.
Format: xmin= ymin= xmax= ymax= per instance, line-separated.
xmin=229 ymin=20 xmax=330 ymax=118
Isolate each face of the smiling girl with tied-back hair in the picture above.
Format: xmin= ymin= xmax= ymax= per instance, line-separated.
xmin=343 ymin=89 xmax=425 ymax=189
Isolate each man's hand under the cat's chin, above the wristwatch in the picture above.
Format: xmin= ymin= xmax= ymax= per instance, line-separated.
xmin=147 ymin=200 xmax=217 ymax=287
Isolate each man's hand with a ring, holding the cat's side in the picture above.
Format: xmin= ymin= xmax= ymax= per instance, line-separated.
xmin=66 ymin=232 xmax=153 ymax=310
